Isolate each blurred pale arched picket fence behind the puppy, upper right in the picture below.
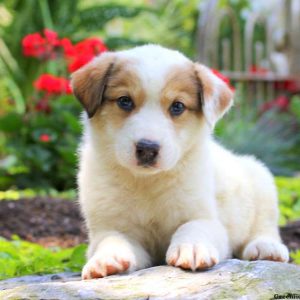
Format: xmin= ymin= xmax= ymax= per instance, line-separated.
xmin=197 ymin=0 xmax=300 ymax=102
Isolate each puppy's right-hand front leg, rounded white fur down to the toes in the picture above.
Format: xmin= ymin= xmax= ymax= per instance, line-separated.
xmin=166 ymin=220 xmax=230 ymax=271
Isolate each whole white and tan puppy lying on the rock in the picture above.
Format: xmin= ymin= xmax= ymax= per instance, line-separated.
xmin=72 ymin=45 xmax=289 ymax=279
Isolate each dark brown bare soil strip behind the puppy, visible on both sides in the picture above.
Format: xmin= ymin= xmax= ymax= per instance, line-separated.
xmin=0 ymin=197 xmax=300 ymax=250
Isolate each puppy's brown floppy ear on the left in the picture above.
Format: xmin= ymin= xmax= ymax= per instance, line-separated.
xmin=71 ymin=52 xmax=115 ymax=118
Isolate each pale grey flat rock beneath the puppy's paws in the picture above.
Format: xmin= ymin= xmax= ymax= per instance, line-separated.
xmin=0 ymin=259 xmax=300 ymax=300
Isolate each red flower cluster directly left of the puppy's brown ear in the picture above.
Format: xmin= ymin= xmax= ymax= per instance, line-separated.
xmin=34 ymin=74 xmax=72 ymax=95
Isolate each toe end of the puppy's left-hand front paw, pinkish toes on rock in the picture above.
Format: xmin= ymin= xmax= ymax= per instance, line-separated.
xmin=81 ymin=239 xmax=136 ymax=279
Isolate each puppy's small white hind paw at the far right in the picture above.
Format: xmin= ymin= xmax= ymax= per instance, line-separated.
xmin=242 ymin=237 xmax=289 ymax=262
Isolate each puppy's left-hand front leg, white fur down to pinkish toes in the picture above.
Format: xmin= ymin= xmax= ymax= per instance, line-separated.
xmin=82 ymin=232 xmax=151 ymax=279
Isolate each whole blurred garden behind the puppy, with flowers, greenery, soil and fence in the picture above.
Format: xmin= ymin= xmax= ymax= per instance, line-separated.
xmin=0 ymin=0 xmax=300 ymax=279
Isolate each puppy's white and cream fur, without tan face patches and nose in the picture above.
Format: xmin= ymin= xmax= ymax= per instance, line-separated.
xmin=78 ymin=45 xmax=288 ymax=279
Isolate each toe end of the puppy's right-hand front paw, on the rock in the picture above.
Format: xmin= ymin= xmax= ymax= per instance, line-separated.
xmin=166 ymin=242 xmax=219 ymax=271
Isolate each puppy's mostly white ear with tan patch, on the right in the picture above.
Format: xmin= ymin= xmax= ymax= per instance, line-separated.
xmin=195 ymin=63 xmax=233 ymax=128
